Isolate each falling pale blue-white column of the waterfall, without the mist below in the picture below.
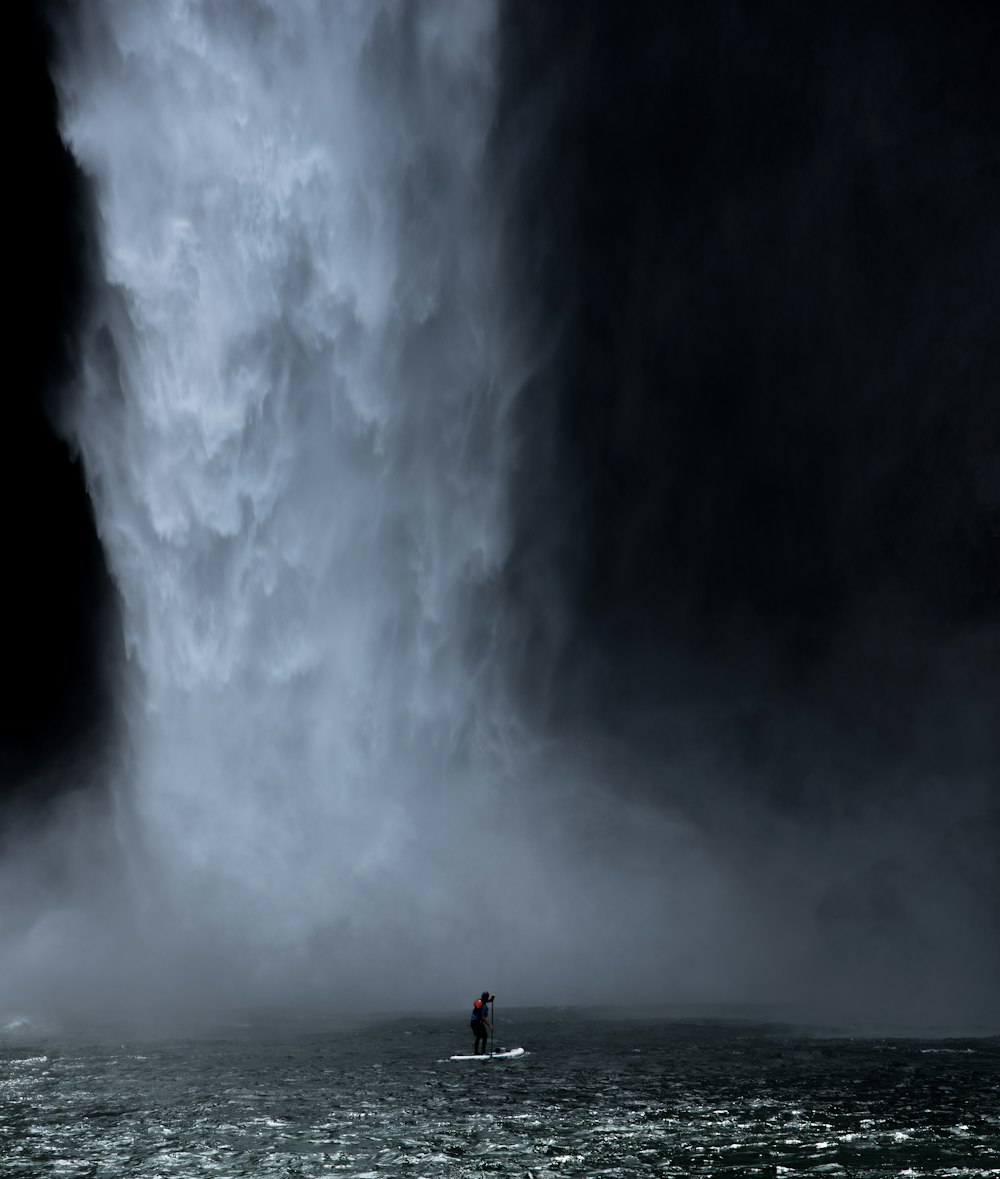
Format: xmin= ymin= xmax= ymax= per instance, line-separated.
xmin=46 ymin=2 xmax=528 ymax=1004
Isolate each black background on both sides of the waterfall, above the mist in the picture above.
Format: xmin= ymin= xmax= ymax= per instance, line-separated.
xmin=7 ymin=0 xmax=1000 ymax=867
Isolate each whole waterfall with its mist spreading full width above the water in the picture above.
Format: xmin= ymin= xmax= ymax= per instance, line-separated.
xmin=0 ymin=0 xmax=996 ymax=1027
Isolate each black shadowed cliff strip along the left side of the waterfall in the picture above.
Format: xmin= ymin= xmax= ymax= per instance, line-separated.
xmin=0 ymin=5 xmax=117 ymax=806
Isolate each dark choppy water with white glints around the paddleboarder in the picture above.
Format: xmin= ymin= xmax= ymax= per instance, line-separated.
xmin=0 ymin=1012 xmax=1000 ymax=1179
